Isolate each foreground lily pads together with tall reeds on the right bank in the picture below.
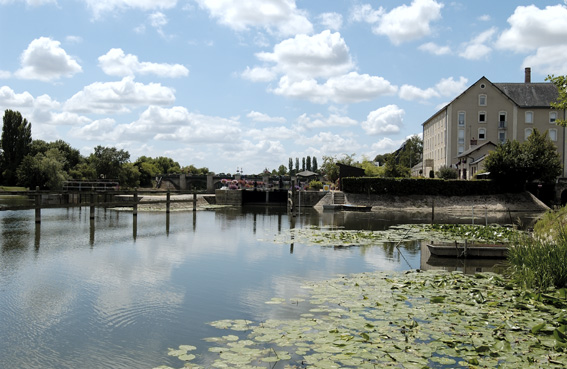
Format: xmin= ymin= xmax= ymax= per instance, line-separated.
xmin=153 ymin=201 xmax=567 ymax=369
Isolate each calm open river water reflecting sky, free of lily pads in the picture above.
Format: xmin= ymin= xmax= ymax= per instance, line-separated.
xmin=0 ymin=208 xmax=540 ymax=368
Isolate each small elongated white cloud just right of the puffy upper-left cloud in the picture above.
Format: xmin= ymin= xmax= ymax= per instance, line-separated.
xmin=98 ymin=49 xmax=189 ymax=78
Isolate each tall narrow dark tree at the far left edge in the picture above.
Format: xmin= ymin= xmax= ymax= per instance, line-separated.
xmin=0 ymin=110 xmax=32 ymax=185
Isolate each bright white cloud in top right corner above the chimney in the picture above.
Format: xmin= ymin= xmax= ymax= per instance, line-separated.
xmin=496 ymin=4 xmax=567 ymax=52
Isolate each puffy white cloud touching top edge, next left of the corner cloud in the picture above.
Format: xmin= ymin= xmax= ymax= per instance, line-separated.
xmin=352 ymin=0 xmax=443 ymax=45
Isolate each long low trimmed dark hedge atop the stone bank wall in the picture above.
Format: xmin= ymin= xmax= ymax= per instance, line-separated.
xmin=341 ymin=177 xmax=524 ymax=196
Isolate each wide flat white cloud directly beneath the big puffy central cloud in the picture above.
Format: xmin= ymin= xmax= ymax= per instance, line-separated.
xmin=274 ymin=72 xmax=397 ymax=104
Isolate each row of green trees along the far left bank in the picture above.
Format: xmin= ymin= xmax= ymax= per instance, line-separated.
xmin=0 ymin=110 xmax=209 ymax=190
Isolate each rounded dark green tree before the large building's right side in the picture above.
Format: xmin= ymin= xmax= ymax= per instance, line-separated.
xmin=484 ymin=129 xmax=561 ymax=184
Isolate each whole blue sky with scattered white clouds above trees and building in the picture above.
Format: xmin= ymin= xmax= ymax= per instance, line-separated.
xmin=0 ymin=0 xmax=567 ymax=174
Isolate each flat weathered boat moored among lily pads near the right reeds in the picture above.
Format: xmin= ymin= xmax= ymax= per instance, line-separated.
xmin=427 ymin=242 xmax=508 ymax=259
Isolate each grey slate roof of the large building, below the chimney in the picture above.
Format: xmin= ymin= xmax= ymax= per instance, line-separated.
xmin=493 ymin=83 xmax=559 ymax=108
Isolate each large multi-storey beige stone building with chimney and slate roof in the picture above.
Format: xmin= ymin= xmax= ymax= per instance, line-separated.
xmin=423 ymin=68 xmax=567 ymax=179
